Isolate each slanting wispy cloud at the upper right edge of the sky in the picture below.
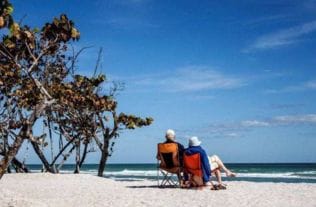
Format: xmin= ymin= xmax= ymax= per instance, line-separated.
xmin=244 ymin=20 xmax=316 ymax=52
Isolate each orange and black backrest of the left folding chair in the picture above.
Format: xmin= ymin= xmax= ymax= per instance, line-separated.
xmin=158 ymin=143 xmax=180 ymax=169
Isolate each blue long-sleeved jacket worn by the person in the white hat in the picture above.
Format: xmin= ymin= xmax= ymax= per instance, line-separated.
xmin=184 ymin=146 xmax=211 ymax=183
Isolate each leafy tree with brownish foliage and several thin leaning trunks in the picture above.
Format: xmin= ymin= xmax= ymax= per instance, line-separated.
xmin=0 ymin=0 xmax=153 ymax=178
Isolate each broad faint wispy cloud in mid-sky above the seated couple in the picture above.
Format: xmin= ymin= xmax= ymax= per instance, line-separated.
xmin=111 ymin=66 xmax=244 ymax=93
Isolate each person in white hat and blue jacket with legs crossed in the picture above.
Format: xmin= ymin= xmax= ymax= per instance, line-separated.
xmin=184 ymin=136 xmax=236 ymax=190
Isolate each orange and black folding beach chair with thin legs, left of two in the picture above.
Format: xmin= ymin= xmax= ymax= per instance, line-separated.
xmin=157 ymin=143 xmax=182 ymax=188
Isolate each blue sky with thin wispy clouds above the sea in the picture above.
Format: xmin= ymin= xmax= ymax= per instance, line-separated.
xmin=12 ymin=0 xmax=316 ymax=163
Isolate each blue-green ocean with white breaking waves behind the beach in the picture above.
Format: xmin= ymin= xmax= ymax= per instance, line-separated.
xmin=24 ymin=163 xmax=316 ymax=183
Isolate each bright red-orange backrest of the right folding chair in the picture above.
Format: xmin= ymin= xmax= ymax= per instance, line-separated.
xmin=183 ymin=153 xmax=203 ymax=177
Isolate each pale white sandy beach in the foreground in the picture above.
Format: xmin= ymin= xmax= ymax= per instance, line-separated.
xmin=0 ymin=174 xmax=316 ymax=207
